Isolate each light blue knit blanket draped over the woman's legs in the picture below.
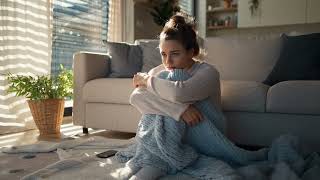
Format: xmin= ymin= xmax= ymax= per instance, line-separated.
xmin=116 ymin=69 xmax=318 ymax=179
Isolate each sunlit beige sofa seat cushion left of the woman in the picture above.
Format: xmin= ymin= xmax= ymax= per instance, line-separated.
xmin=82 ymin=78 xmax=134 ymax=104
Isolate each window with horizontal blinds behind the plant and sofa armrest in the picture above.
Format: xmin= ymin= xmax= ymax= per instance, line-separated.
xmin=51 ymin=0 xmax=109 ymax=75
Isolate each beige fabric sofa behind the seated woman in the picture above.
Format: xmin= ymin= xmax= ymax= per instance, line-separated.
xmin=73 ymin=38 xmax=320 ymax=151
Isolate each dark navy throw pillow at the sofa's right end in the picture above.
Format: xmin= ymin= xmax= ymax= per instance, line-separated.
xmin=263 ymin=33 xmax=320 ymax=86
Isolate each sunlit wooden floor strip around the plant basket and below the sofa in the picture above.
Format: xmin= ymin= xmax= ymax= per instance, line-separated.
xmin=0 ymin=116 xmax=135 ymax=147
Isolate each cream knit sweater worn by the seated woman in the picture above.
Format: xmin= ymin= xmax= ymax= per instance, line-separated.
xmin=130 ymin=62 xmax=221 ymax=128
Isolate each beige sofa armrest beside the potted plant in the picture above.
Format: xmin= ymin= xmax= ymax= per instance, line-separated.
xmin=73 ymin=52 xmax=110 ymax=126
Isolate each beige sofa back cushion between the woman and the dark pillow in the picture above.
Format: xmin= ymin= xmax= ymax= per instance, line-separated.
xmin=205 ymin=37 xmax=281 ymax=82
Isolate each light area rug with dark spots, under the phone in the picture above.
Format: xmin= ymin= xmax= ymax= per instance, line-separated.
xmin=0 ymin=136 xmax=193 ymax=180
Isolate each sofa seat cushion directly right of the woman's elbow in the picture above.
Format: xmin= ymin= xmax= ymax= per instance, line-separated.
xmin=221 ymin=80 xmax=269 ymax=112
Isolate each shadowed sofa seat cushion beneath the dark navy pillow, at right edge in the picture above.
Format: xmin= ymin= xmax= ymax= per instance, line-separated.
xmin=266 ymin=80 xmax=320 ymax=115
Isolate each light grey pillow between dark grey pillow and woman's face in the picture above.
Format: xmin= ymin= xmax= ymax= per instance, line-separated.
xmin=136 ymin=40 xmax=162 ymax=72
